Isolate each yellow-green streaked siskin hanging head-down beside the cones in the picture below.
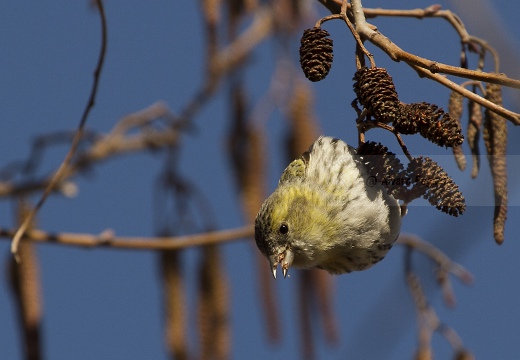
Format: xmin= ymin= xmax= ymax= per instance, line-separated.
xmin=255 ymin=136 xmax=401 ymax=279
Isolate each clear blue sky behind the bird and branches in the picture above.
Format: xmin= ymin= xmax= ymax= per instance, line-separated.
xmin=0 ymin=0 xmax=520 ymax=359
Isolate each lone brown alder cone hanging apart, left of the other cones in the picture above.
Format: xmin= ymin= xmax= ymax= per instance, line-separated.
xmin=300 ymin=27 xmax=334 ymax=81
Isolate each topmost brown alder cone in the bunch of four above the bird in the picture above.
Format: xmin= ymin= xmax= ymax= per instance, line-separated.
xmin=353 ymin=67 xmax=400 ymax=123
